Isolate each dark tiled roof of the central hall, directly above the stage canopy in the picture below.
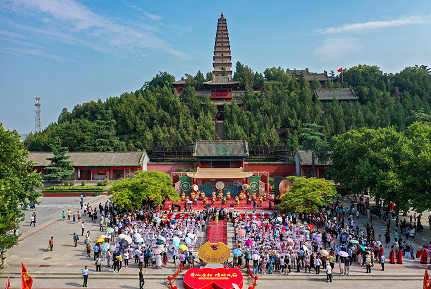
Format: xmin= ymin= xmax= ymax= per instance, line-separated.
xmin=193 ymin=140 xmax=249 ymax=157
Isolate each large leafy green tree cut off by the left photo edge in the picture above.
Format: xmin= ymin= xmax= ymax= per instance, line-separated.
xmin=0 ymin=123 xmax=42 ymax=267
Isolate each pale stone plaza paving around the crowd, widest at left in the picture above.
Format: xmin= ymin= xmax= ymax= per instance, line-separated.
xmin=0 ymin=195 xmax=431 ymax=289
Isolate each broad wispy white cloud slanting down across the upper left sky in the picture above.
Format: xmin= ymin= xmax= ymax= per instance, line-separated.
xmin=4 ymin=0 xmax=188 ymax=59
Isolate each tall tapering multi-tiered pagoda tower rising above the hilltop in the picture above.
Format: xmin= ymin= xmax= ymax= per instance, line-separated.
xmin=213 ymin=13 xmax=232 ymax=76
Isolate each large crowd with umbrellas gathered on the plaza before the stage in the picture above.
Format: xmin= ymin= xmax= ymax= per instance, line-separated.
xmin=63 ymin=191 xmax=431 ymax=282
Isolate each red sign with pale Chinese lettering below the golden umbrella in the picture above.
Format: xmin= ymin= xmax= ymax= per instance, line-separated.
xmin=184 ymin=268 xmax=244 ymax=289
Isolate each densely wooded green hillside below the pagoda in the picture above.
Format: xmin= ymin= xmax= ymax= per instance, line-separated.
xmin=25 ymin=62 xmax=431 ymax=151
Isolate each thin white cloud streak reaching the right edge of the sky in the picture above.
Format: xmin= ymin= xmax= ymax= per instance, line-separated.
xmin=317 ymin=16 xmax=431 ymax=34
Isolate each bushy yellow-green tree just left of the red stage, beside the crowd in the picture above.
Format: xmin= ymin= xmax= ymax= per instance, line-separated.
xmin=109 ymin=171 xmax=180 ymax=210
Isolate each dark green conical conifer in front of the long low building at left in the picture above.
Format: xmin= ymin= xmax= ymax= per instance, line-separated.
xmin=45 ymin=137 xmax=73 ymax=182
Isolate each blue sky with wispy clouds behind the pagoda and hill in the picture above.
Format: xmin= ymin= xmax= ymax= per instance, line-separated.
xmin=0 ymin=0 xmax=431 ymax=134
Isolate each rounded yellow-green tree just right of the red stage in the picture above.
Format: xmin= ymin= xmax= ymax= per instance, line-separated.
xmin=279 ymin=176 xmax=337 ymax=213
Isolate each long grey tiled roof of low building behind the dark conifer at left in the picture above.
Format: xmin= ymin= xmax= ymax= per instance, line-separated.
xmin=28 ymin=152 xmax=145 ymax=167
